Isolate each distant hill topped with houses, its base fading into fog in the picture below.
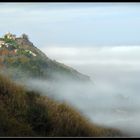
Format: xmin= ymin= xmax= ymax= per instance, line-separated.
xmin=0 ymin=33 xmax=90 ymax=81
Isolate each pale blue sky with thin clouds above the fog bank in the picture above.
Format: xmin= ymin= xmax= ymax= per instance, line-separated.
xmin=0 ymin=3 xmax=140 ymax=48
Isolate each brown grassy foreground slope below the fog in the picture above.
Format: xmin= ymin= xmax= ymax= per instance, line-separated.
xmin=0 ymin=75 xmax=122 ymax=137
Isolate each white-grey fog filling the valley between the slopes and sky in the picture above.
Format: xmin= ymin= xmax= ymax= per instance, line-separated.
xmin=28 ymin=46 xmax=140 ymax=136
